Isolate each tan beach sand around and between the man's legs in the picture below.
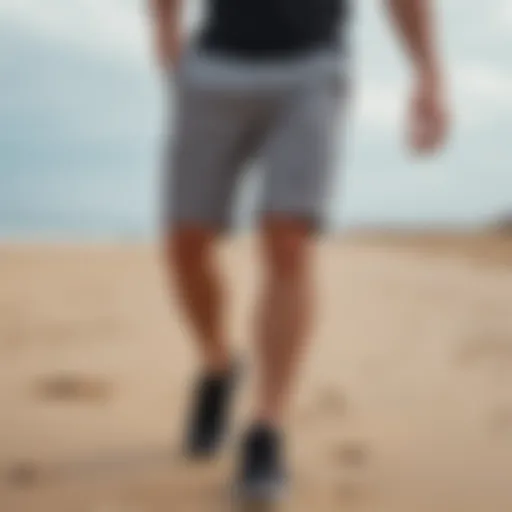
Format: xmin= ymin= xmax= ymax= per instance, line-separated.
xmin=0 ymin=235 xmax=512 ymax=512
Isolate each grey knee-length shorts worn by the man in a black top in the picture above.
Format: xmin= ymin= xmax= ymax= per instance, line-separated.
xmin=164 ymin=50 xmax=345 ymax=230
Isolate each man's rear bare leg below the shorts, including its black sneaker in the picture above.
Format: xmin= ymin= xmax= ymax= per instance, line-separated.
xmin=167 ymin=226 xmax=242 ymax=457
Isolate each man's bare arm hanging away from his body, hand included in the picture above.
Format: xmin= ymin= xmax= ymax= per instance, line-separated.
xmin=387 ymin=0 xmax=447 ymax=151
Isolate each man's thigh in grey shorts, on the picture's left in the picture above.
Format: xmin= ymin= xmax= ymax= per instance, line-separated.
xmin=165 ymin=82 xmax=264 ymax=228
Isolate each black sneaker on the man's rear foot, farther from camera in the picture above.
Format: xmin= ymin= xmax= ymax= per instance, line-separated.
xmin=185 ymin=366 xmax=238 ymax=458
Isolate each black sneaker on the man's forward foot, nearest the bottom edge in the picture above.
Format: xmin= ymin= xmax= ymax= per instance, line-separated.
xmin=235 ymin=425 xmax=287 ymax=504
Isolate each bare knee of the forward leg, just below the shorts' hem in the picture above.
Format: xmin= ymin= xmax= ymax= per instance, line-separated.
xmin=263 ymin=216 xmax=311 ymax=279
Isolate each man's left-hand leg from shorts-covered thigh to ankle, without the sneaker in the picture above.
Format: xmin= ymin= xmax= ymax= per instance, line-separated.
xmin=165 ymin=79 xmax=262 ymax=373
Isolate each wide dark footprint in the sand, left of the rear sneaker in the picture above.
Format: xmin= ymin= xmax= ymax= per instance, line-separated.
xmin=34 ymin=374 xmax=112 ymax=402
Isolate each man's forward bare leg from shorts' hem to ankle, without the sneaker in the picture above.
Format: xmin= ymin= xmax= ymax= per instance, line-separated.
xmin=256 ymin=217 xmax=312 ymax=426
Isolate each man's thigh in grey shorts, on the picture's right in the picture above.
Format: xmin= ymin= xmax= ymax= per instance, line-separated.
xmin=262 ymin=77 xmax=344 ymax=230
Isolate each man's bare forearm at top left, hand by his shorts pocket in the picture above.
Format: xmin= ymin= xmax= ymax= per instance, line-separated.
xmin=149 ymin=0 xmax=183 ymax=70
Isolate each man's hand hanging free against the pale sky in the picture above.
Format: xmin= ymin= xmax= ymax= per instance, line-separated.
xmin=408 ymin=74 xmax=448 ymax=154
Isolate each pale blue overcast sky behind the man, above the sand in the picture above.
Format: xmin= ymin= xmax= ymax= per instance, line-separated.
xmin=0 ymin=0 xmax=512 ymax=236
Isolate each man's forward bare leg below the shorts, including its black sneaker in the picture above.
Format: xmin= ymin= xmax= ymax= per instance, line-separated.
xmin=237 ymin=215 xmax=313 ymax=501
